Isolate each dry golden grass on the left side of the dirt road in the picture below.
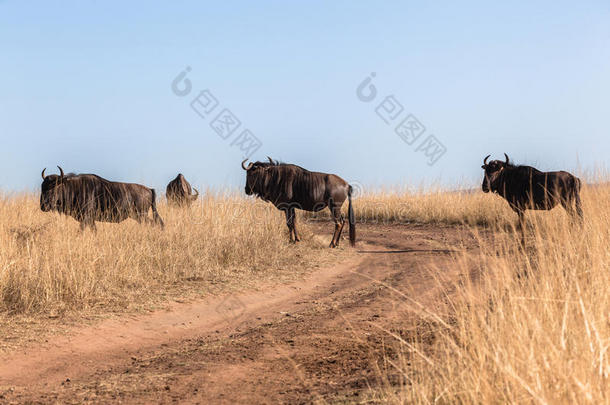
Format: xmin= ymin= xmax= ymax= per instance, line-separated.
xmin=0 ymin=194 xmax=339 ymax=316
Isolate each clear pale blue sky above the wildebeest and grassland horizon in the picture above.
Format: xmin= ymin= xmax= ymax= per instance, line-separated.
xmin=0 ymin=0 xmax=610 ymax=190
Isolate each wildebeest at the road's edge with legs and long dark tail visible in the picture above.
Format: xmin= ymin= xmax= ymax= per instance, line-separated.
xmin=241 ymin=158 xmax=356 ymax=247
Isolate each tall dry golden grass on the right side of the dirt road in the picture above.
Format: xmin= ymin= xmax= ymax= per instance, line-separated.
xmin=366 ymin=187 xmax=610 ymax=404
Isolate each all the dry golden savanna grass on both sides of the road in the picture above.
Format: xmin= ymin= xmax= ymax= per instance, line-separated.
xmin=0 ymin=186 xmax=610 ymax=403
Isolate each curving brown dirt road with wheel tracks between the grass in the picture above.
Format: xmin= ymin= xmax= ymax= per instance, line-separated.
xmin=0 ymin=224 xmax=474 ymax=404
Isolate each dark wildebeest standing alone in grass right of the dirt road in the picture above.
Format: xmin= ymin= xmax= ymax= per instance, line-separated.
xmin=481 ymin=153 xmax=583 ymax=242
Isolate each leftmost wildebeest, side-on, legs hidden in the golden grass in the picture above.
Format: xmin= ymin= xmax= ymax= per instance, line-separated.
xmin=40 ymin=166 xmax=164 ymax=230
